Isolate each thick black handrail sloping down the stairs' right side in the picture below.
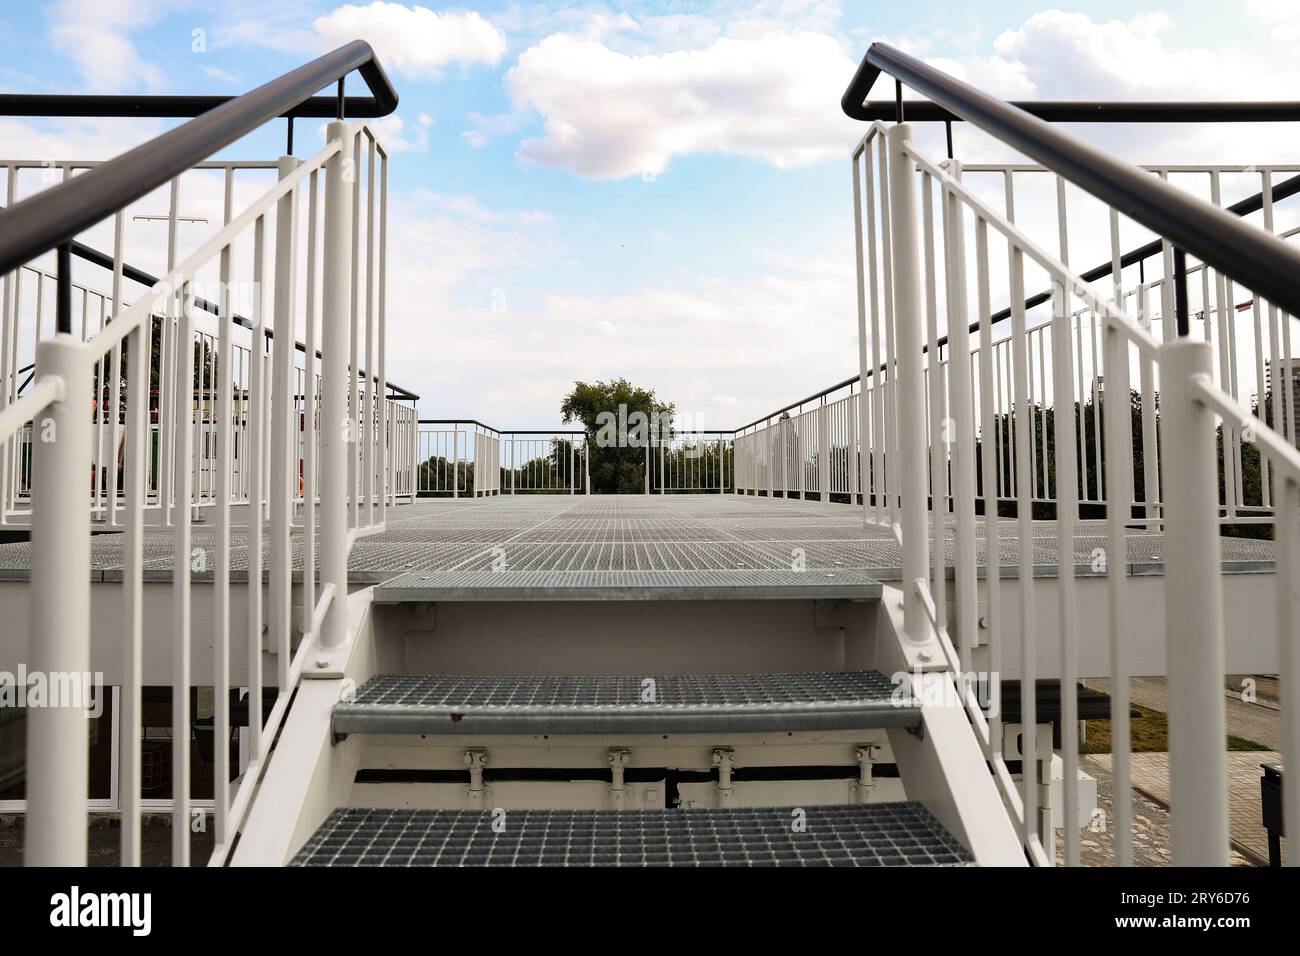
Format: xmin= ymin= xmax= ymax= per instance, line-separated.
xmin=841 ymin=43 xmax=1300 ymax=330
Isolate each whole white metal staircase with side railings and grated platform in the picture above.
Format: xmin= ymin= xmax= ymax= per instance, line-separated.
xmin=0 ymin=35 xmax=1300 ymax=866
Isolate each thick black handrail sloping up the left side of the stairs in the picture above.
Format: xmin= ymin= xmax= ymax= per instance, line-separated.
xmin=0 ymin=40 xmax=398 ymax=280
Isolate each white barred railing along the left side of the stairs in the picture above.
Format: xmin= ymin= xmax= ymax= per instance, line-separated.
xmin=0 ymin=121 xmax=416 ymax=865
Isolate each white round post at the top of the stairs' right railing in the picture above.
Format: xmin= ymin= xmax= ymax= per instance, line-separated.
xmin=888 ymin=124 xmax=930 ymax=643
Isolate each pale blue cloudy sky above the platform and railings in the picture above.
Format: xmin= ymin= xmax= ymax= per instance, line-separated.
xmin=0 ymin=0 xmax=1300 ymax=428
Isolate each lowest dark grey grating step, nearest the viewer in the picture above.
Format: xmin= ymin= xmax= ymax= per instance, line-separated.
xmin=291 ymin=803 xmax=974 ymax=866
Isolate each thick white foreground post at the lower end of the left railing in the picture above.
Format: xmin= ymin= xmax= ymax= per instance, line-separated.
xmin=23 ymin=333 xmax=91 ymax=866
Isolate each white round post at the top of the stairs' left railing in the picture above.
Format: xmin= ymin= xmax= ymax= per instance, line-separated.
xmin=320 ymin=120 xmax=355 ymax=648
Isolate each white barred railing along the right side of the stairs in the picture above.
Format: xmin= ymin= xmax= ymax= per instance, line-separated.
xmin=842 ymin=122 xmax=1300 ymax=865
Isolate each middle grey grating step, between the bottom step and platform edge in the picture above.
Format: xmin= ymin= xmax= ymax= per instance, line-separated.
xmin=333 ymin=671 xmax=920 ymax=735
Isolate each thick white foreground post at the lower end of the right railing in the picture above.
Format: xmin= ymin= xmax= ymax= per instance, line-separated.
xmin=1160 ymin=338 xmax=1227 ymax=866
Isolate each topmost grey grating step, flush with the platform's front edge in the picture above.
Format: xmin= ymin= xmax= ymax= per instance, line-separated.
xmin=374 ymin=567 xmax=881 ymax=604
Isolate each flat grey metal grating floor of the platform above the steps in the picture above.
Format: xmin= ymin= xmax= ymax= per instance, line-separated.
xmin=0 ymin=494 xmax=1274 ymax=587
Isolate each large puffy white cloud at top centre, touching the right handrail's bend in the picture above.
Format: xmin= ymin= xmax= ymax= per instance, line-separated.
xmin=506 ymin=33 xmax=855 ymax=178
